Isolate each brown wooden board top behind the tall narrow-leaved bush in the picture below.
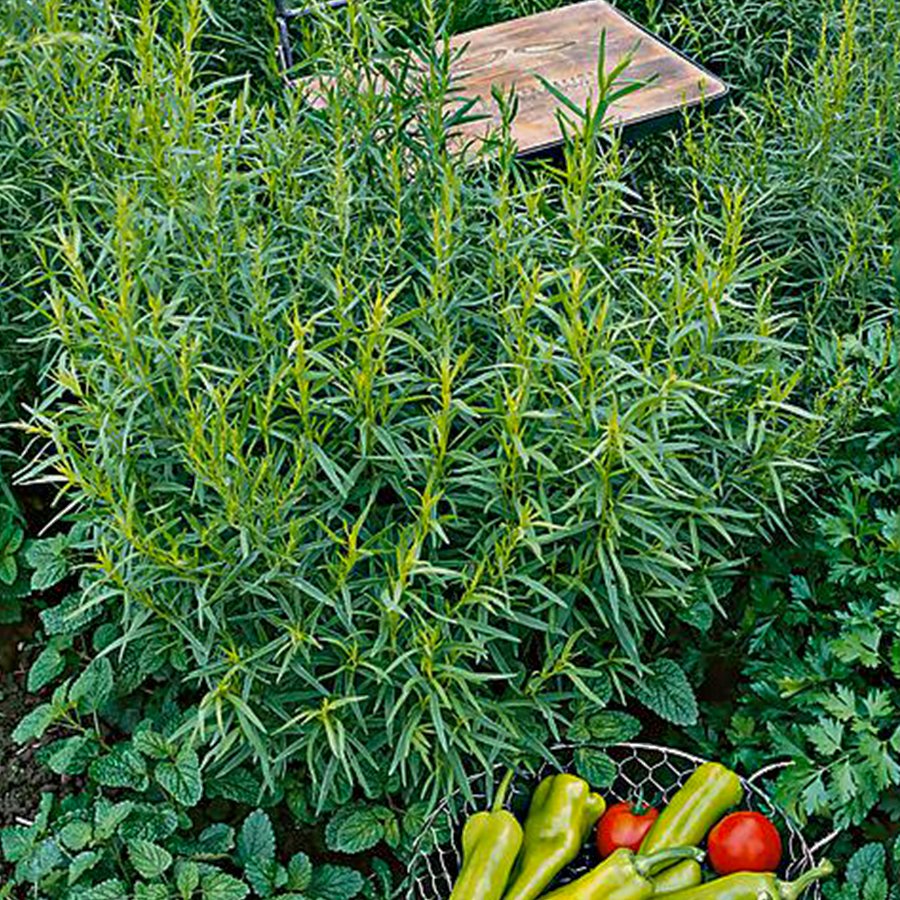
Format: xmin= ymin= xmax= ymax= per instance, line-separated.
xmin=298 ymin=0 xmax=728 ymax=154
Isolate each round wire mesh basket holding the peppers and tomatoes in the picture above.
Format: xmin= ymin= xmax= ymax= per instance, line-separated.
xmin=404 ymin=744 xmax=821 ymax=900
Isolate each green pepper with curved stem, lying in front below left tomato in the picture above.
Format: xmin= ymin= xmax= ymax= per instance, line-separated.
xmin=545 ymin=847 xmax=703 ymax=900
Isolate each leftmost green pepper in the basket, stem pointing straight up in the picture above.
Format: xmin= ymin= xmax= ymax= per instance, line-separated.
xmin=450 ymin=769 xmax=522 ymax=900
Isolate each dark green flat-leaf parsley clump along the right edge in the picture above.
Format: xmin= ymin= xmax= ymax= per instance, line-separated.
xmin=684 ymin=330 xmax=900 ymax=829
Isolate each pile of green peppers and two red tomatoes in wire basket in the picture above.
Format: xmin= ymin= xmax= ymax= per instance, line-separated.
xmin=450 ymin=763 xmax=834 ymax=900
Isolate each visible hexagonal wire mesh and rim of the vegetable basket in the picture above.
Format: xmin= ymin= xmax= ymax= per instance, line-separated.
xmin=398 ymin=742 xmax=824 ymax=900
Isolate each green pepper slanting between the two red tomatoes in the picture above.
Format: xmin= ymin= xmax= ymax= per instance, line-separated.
xmin=640 ymin=763 xmax=744 ymax=868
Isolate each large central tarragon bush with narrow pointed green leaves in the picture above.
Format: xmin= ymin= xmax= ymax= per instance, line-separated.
xmin=7 ymin=3 xmax=821 ymax=799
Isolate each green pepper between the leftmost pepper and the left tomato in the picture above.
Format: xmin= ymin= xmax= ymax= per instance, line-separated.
xmin=503 ymin=775 xmax=606 ymax=900
